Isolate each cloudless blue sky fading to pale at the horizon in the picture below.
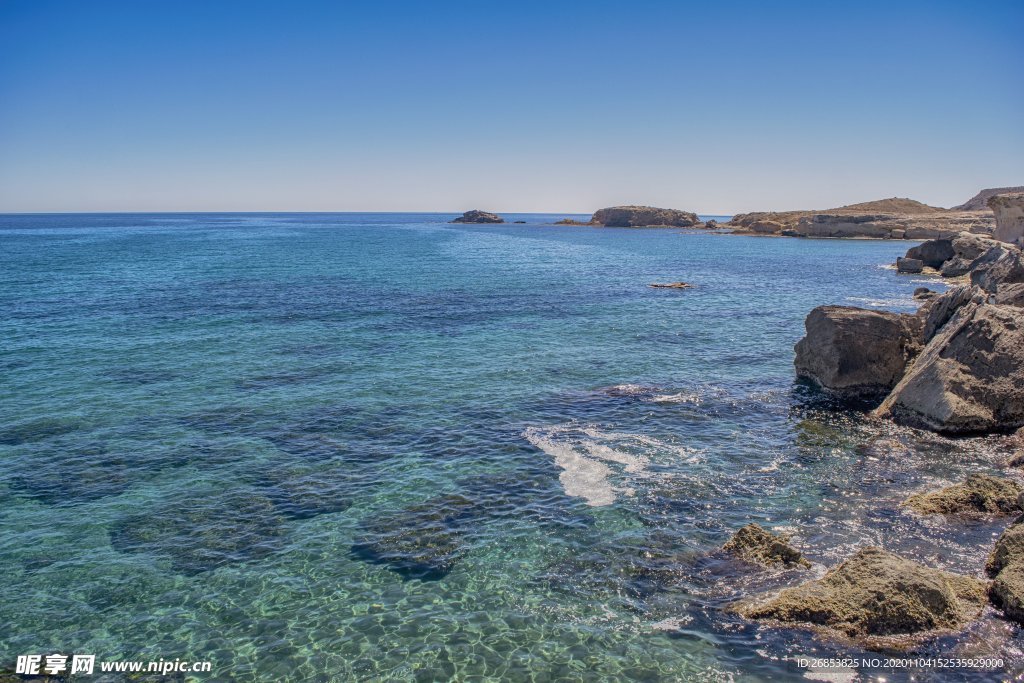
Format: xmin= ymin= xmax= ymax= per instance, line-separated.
xmin=0 ymin=0 xmax=1024 ymax=213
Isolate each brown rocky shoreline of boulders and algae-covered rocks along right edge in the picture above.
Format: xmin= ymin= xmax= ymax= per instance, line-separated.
xmin=723 ymin=194 xmax=1024 ymax=649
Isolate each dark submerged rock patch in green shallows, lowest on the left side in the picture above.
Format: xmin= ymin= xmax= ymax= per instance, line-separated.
xmin=111 ymin=489 xmax=281 ymax=574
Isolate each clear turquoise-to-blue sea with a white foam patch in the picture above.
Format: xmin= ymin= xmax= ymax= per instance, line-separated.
xmin=0 ymin=214 xmax=1022 ymax=681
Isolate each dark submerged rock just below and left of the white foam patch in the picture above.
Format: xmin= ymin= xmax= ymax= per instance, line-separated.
xmin=352 ymin=495 xmax=476 ymax=581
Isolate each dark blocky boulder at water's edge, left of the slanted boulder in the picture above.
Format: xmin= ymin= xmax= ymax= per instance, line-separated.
xmin=794 ymin=306 xmax=921 ymax=398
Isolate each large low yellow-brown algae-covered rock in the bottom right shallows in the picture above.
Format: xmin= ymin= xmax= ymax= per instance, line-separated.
xmin=739 ymin=548 xmax=986 ymax=642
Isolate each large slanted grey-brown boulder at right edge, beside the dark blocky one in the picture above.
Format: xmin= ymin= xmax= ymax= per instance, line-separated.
xmin=876 ymin=301 xmax=1024 ymax=433
